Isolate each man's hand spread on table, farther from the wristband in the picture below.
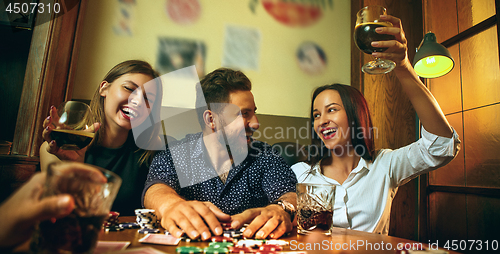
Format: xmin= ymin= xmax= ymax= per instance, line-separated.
xmin=161 ymin=200 xmax=231 ymax=240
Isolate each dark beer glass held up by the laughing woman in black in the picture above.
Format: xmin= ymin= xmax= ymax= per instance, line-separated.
xmin=50 ymin=101 xmax=94 ymax=150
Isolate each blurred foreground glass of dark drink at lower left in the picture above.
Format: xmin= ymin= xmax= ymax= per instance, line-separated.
xmin=31 ymin=162 xmax=122 ymax=254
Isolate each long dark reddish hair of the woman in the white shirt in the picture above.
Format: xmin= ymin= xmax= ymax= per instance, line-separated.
xmin=309 ymin=84 xmax=375 ymax=166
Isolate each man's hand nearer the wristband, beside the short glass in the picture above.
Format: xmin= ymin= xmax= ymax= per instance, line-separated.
xmin=231 ymin=204 xmax=293 ymax=239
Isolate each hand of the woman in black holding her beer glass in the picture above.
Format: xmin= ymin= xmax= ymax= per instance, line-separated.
xmin=42 ymin=106 xmax=100 ymax=162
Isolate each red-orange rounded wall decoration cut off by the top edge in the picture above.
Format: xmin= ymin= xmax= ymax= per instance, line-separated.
xmin=258 ymin=0 xmax=333 ymax=27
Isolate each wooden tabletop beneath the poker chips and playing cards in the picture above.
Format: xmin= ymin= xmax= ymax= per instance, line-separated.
xmin=94 ymin=216 xmax=457 ymax=254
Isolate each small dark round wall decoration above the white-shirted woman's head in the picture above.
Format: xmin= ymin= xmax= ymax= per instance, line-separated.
xmin=296 ymin=41 xmax=327 ymax=75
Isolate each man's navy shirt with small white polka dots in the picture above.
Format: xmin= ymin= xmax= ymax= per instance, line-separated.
xmin=142 ymin=133 xmax=297 ymax=215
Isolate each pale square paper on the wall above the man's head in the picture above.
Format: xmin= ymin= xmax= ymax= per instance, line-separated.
xmin=222 ymin=25 xmax=261 ymax=70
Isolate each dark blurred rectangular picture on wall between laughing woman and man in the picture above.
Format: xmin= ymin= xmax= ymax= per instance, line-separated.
xmin=156 ymin=37 xmax=205 ymax=77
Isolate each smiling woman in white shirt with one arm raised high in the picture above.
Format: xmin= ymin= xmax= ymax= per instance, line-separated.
xmin=292 ymin=15 xmax=460 ymax=234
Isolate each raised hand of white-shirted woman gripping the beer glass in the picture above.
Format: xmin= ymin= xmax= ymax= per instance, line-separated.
xmin=372 ymin=15 xmax=411 ymax=68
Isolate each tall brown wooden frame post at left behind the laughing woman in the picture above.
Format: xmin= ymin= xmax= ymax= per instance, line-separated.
xmin=12 ymin=0 xmax=86 ymax=156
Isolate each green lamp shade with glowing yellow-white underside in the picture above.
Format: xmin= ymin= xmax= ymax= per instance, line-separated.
xmin=413 ymin=32 xmax=455 ymax=78
